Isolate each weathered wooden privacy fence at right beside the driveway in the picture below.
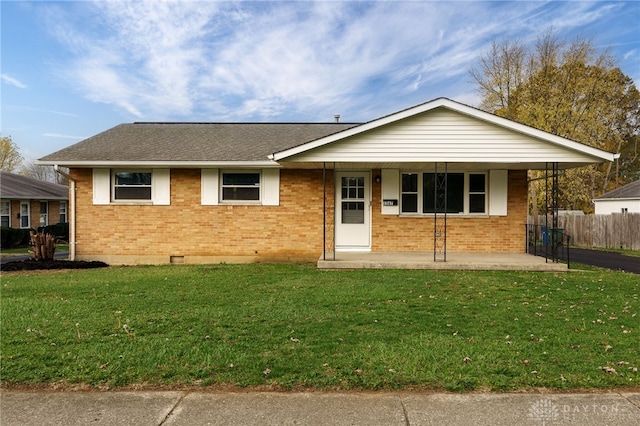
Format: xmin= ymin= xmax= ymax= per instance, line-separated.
xmin=529 ymin=213 xmax=640 ymax=250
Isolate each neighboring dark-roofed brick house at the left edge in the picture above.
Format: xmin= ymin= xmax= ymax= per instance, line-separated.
xmin=0 ymin=172 xmax=69 ymax=229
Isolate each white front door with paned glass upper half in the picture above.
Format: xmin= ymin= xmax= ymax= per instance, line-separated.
xmin=336 ymin=172 xmax=371 ymax=250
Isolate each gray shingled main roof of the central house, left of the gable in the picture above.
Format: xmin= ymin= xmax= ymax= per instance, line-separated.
xmin=39 ymin=123 xmax=358 ymax=164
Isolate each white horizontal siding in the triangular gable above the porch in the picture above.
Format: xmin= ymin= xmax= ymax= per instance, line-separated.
xmin=287 ymin=109 xmax=604 ymax=163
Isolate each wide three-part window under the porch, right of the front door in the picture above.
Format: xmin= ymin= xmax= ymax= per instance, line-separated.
xmin=400 ymin=172 xmax=487 ymax=214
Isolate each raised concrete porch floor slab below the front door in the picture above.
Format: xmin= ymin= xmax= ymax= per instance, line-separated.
xmin=318 ymin=252 xmax=568 ymax=272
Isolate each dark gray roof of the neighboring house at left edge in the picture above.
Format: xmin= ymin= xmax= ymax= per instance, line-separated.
xmin=0 ymin=172 xmax=69 ymax=200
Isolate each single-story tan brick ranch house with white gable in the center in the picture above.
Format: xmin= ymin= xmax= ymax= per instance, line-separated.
xmin=38 ymin=98 xmax=615 ymax=264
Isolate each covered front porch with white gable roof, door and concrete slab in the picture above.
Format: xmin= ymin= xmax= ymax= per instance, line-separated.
xmin=269 ymin=98 xmax=615 ymax=271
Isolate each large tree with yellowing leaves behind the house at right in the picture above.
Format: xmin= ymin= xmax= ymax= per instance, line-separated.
xmin=470 ymin=31 xmax=640 ymax=211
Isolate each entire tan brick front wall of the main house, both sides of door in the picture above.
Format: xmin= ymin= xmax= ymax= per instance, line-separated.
xmin=71 ymin=169 xmax=527 ymax=264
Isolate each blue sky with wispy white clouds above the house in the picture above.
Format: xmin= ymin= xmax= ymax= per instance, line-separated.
xmin=0 ymin=0 xmax=640 ymax=161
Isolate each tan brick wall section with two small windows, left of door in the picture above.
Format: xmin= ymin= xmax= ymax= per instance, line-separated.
xmin=71 ymin=169 xmax=333 ymax=263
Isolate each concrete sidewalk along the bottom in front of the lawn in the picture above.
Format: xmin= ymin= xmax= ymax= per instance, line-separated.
xmin=0 ymin=391 xmax=640 ymax=426
